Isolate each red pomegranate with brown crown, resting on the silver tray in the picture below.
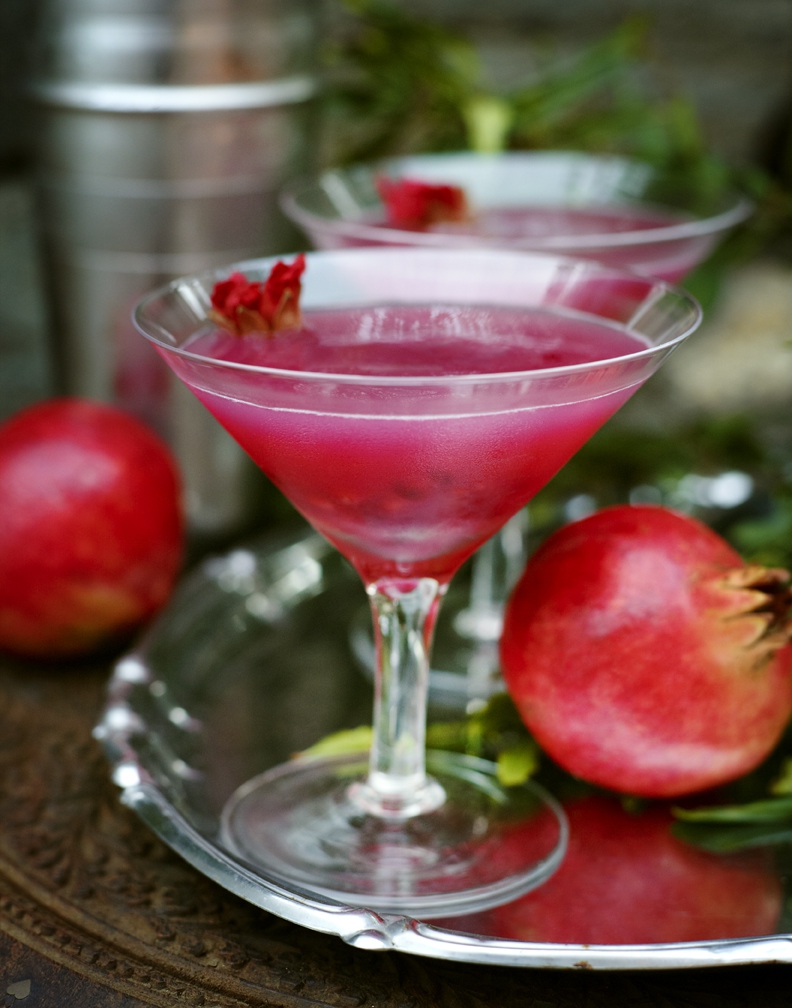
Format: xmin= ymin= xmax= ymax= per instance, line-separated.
xmin=501 ymin=505 xmax=792 ymax=797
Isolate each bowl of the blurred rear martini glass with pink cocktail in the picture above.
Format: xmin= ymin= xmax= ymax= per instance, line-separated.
xmin=282 ymin=151 xmax=752 ymax=283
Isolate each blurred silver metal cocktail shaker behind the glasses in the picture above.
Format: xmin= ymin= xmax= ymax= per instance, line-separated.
xmin=32 ymin=0 xmax=316 ymax=534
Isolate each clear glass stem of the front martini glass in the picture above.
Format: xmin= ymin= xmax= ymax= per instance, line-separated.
xmin=351 ymin=578 xmax=445 ymax=818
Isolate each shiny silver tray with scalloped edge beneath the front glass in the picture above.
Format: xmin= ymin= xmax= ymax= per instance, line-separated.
xmin=96 ymin=529 xmax=792 ymax=970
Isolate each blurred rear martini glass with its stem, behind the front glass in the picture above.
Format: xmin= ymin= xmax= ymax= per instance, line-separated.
xmin=282 ymin=151 xmax=753 ymax=709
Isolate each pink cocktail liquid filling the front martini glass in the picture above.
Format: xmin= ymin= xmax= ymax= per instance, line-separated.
xmin=186 ymin=305 xmax=646 ymax=582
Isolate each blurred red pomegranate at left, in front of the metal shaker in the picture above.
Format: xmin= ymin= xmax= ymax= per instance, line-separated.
xmin=0 ymin=398 xmax=183 ymax=658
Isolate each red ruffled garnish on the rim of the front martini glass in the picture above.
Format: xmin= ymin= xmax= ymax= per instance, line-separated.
xmin=209 ymin=254 xmax=305 ymax=336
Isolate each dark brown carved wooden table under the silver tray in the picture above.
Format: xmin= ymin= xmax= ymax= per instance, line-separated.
xmin=0 ymin=658 xmax=792 ymax=1008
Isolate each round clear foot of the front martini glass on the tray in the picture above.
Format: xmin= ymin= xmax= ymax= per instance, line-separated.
xmin=223 ymin=752 xmax=568 ymax=918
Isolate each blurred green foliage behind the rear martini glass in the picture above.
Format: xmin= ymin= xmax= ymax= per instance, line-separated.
xmin=325 ymin=0 xmax=792 ymax=272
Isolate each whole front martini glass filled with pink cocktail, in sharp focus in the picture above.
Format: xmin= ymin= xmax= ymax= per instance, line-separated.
xmin=135 ymin=249 xmax=700 ymax=917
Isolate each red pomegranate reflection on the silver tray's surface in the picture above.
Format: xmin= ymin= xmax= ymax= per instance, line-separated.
xmin=481 ymin=796 xmax=782 ymax=944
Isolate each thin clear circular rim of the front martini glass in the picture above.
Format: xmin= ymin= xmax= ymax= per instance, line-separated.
xmin=132 ymin=246 xmax=703 ymax=387
